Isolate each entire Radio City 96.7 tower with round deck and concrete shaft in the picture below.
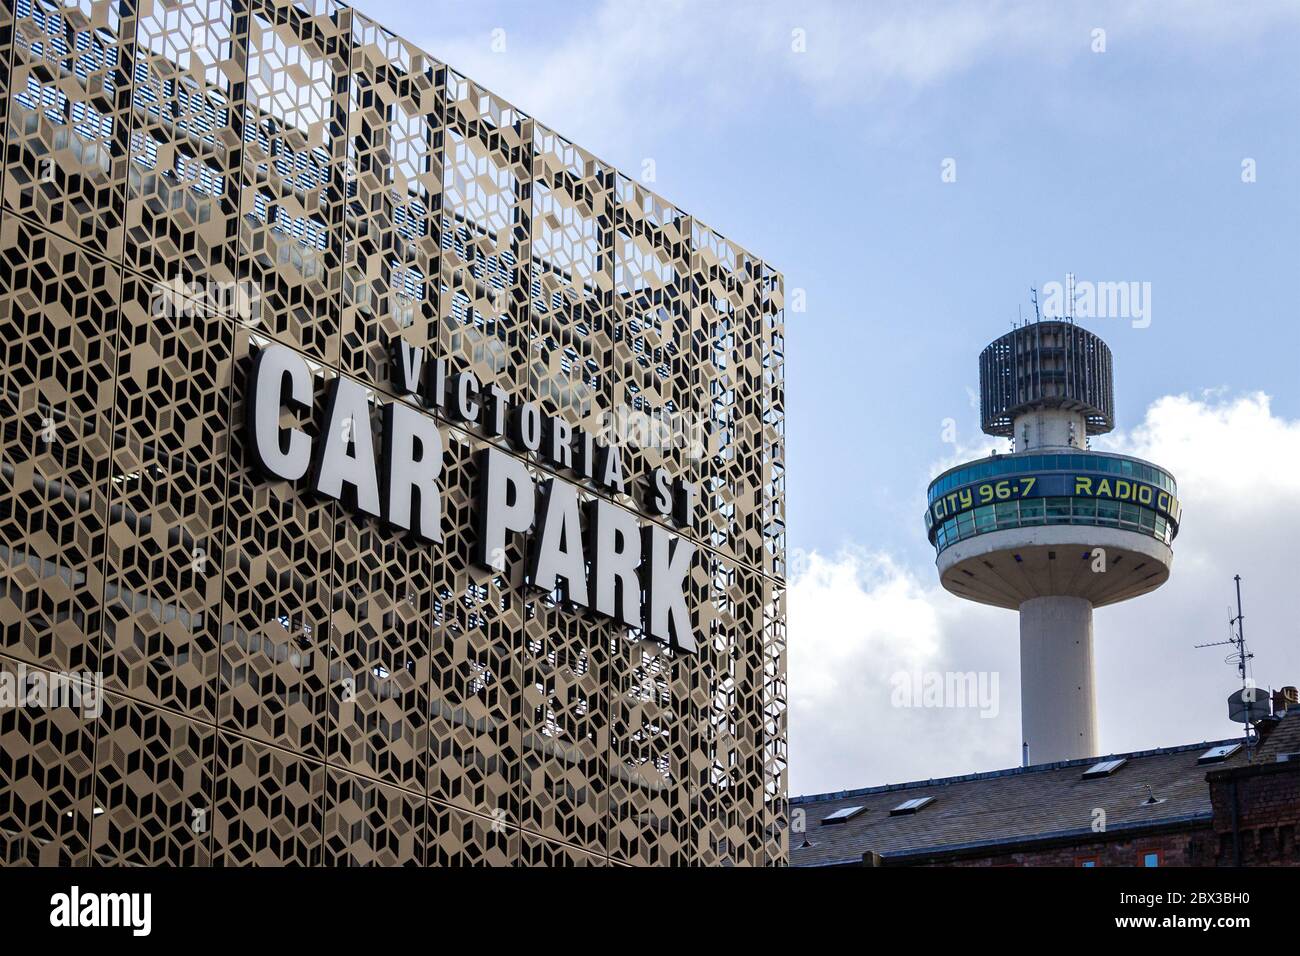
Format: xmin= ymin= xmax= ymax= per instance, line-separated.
xmin=926 ymin=321 xmax=1180 ymax=763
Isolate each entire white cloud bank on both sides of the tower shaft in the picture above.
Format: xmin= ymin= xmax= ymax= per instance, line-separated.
xmin=788 ymin=393 xmax=1300 ymax=793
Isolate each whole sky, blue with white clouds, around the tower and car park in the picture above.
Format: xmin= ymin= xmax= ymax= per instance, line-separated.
xmin=359 ymin=0 xmax=1300 ymax=791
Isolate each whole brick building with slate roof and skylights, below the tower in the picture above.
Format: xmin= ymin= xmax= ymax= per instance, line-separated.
xmin=790 ymin=698 xmax=1300 ymax=866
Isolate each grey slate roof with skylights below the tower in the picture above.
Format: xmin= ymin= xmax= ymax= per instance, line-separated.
xmin=790 ymin=733 xmax=1263 ymax=866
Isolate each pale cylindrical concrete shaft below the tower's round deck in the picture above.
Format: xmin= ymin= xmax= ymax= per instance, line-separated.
xmin=1021 ymin=596 xmax=1099 ymax=763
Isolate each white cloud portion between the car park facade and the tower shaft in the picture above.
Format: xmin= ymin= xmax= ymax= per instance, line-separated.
xmin=787 ymin=550 xmax=1019 ymax=793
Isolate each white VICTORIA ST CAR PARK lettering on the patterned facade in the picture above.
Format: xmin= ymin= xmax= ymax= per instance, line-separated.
xmin=244 ymin=338 xmax=697 ymax=652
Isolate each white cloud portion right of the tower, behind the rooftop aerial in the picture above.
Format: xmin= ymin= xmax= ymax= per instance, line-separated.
xmin=1096 ymin=392 xmax=1300 ymax=749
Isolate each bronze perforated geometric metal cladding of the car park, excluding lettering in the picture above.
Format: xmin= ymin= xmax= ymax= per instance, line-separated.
xmin=0 ymin=0 xmax=788 ymax=865
